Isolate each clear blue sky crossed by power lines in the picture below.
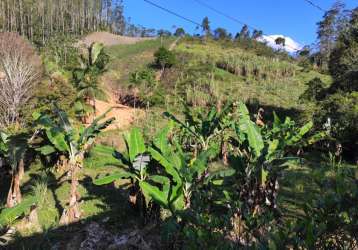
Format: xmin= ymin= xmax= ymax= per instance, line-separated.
xmin=124 ymin=0 xmax=358 ymax=44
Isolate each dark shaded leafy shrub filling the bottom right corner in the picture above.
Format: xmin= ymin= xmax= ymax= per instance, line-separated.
xmin=269 ymin=154 xmax=358 ymax=249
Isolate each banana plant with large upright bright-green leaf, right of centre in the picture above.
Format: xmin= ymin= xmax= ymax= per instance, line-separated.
xmin=206 ymin=103 xmax=318 ymax=229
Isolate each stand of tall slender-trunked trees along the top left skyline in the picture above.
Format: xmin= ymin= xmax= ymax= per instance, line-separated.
xmin=0 ymin=0 xmax=125 ymax=44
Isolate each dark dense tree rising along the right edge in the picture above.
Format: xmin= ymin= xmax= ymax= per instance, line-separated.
xmin=310 ymin=8 xmax=358 ymax=158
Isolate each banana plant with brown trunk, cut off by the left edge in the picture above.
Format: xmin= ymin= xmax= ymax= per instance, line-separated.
xmin=0 ymin=131 xmax=30 ymax=208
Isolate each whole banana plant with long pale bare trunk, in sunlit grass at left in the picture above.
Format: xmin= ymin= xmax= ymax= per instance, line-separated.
xmin=33 ymin=105 xmax=114 ymax=224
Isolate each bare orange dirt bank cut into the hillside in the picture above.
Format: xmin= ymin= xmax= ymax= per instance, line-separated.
xmin=96 ymin=91 xmax=144 ymax=131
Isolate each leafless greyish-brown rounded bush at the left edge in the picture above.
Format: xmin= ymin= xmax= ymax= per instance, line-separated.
xmin=0 ymin=32 xmax=42 ymax=128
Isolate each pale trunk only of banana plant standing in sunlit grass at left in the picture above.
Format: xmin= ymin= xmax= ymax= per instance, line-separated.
xmin=60 ymin=163 xmax=81 ymax=225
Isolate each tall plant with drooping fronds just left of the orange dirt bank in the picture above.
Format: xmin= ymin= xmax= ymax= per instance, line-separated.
xmin=73 ymin=43 xmax=108 ymax=123
